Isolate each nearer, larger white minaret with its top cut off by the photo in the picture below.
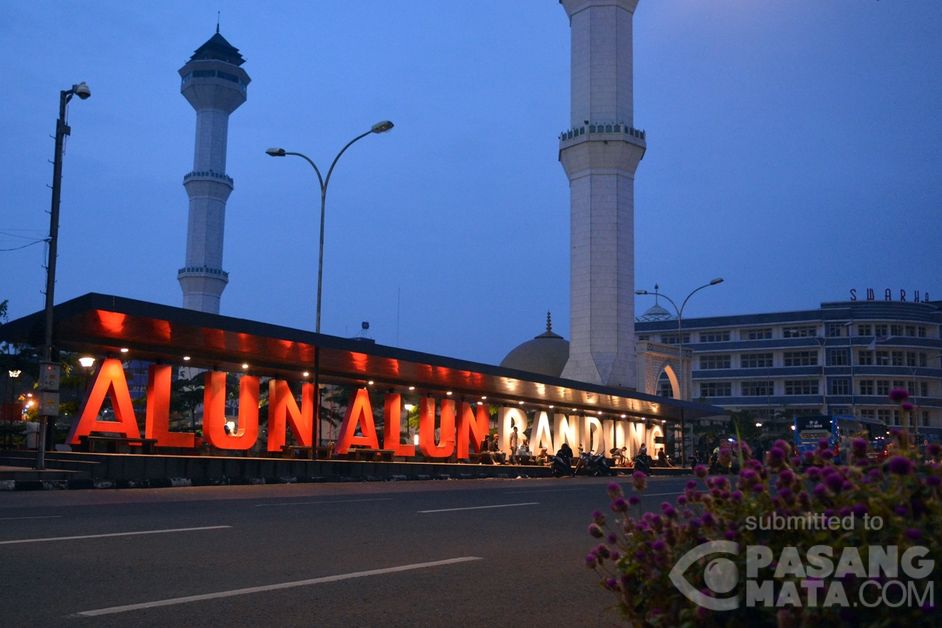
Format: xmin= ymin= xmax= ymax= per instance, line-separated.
xmin=559 ymin=0 xmax=645 ymax=388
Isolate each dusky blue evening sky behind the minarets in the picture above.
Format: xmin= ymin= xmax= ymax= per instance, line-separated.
xmin=0 ymin=0 xmax=942 ymax=363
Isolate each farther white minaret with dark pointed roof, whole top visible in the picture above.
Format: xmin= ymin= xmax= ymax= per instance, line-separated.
xmin=177 ymin=25 xmax=251 ymax=314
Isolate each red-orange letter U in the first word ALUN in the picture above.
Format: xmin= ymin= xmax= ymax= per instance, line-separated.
xmin=203 ymin=371 xmax=258 ymax=450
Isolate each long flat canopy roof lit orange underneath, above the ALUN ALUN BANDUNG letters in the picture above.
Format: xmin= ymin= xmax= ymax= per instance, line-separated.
xmin=0 ymin=293 xmax=724 ymax=422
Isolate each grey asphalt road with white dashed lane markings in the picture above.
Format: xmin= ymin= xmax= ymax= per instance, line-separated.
xmin=0 ymin=478 xmax=687 ymax=627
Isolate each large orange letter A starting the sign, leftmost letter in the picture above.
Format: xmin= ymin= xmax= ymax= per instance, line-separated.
xmin=69 ymin=358 xmax=141 ymax=445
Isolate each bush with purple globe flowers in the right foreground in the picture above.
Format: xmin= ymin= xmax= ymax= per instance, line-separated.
xmin=585 ymin=418 xmax=942 ymax=628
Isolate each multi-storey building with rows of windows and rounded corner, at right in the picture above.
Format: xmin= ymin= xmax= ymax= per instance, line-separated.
xmin=636 ymin=299 xmax=942 ymax=433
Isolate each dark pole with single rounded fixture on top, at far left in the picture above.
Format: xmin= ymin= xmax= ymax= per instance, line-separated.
xmin=36 ymin=82 xmax=92 ymax=469
